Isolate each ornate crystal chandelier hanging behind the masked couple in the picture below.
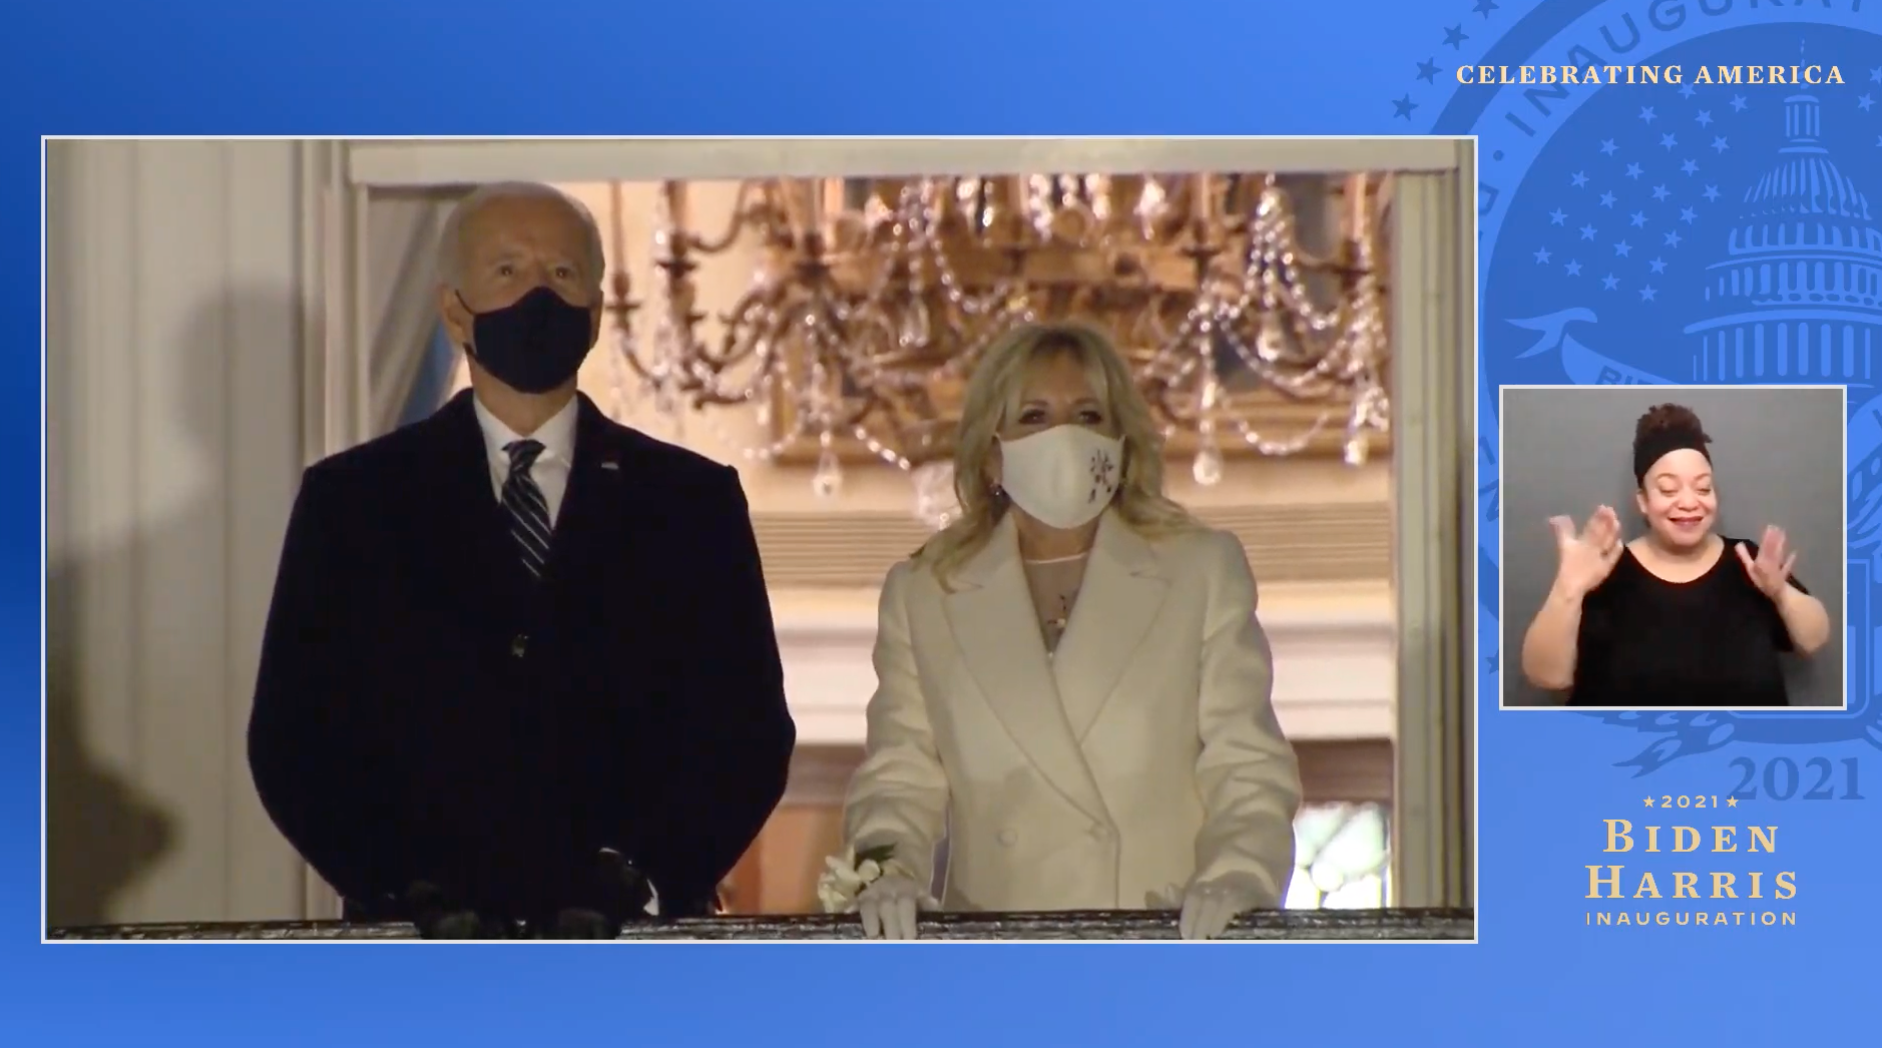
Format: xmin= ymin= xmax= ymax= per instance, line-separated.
xmin=608 ymin=173 xmax=1391 ymax=523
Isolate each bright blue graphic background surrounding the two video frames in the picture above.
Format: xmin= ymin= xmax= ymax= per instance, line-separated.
xmin=18 ymin=0 xmax=1882 ymax=1046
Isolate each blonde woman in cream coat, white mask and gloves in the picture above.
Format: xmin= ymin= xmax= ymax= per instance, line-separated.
xmin=821 ymin=326 xmax=1300 ymax=939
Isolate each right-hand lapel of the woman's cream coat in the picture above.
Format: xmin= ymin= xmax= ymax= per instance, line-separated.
xmin=1052 ymin=512 xmax=1169 ymax=739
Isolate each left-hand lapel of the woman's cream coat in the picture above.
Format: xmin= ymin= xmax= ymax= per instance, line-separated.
xmin=945 ymin=517 xmax=1110 ymax=824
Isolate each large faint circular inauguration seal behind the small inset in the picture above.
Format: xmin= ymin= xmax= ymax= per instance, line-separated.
xmin=1415 ymin=0 xmax=1882 ymax=775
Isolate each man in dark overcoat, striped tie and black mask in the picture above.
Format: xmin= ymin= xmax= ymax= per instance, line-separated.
xmin=248 ymin=184 xmax=794 ymax=937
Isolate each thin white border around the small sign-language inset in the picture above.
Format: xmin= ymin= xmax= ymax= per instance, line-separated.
xmin=1477 ymin=382 xmax=1850 ymax=713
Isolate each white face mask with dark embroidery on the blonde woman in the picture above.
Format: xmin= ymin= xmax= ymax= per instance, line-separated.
xmin=999 ymin=423 xmax=1124 ymax=529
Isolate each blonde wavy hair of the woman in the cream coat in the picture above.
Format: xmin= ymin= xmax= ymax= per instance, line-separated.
xmin=915 ymin=324 xmax=1201 ymax=583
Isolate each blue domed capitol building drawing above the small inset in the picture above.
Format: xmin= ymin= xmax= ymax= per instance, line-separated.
xmin=1686 ymin=94 xmax=1882 ymax=386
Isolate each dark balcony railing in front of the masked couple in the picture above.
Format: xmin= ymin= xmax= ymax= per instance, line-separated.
xmin=47 ymin=909 xmax=1477 ymax=943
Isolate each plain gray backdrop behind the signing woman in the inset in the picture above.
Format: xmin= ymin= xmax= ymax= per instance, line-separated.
xmin=1498 ymin=386 xmax=1846 ymax=707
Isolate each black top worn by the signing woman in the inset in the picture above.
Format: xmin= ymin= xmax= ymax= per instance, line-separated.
xmin=1568 ymin=538 xmax=1809 ymax=709
